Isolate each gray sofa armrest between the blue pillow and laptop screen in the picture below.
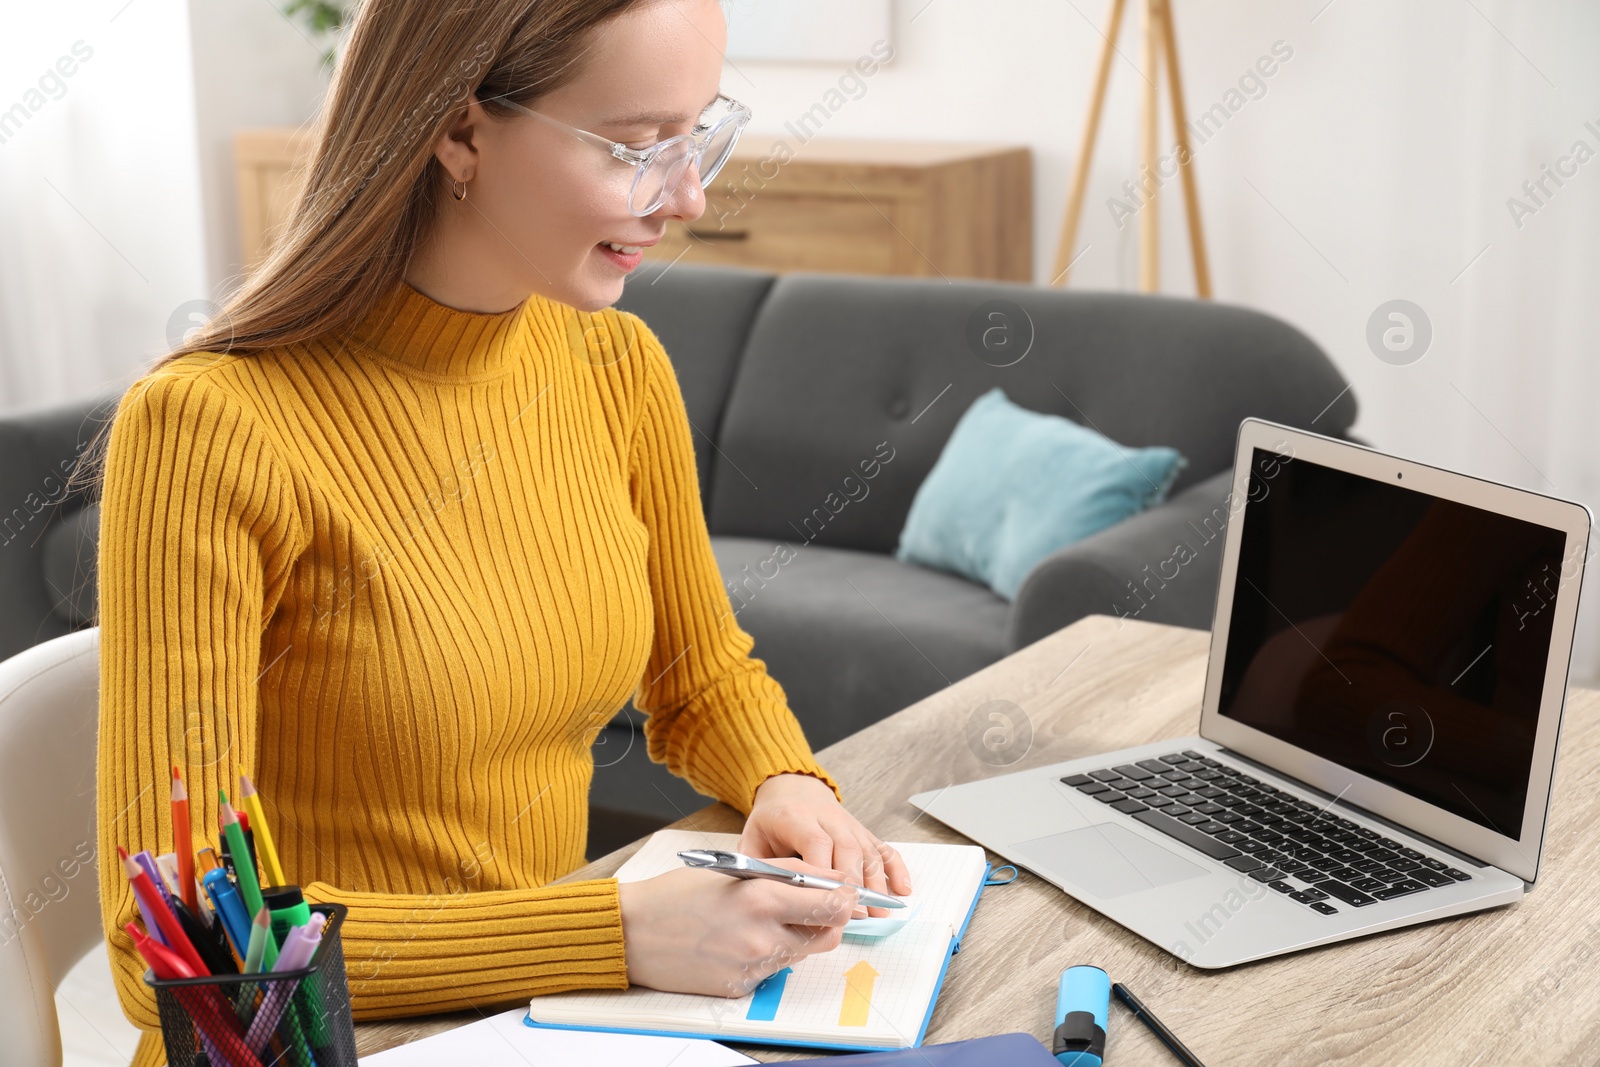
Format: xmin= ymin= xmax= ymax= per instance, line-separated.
xmin=1006 ymin=470 xmax=1243 ymax=651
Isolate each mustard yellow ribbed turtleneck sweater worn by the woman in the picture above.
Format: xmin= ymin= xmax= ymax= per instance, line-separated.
xmin=98 ymin=283 xmax=837 ymax=1067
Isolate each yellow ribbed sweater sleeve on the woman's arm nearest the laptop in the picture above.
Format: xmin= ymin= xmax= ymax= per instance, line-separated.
xmin=626 ymin=315 xmax=838 ymax=813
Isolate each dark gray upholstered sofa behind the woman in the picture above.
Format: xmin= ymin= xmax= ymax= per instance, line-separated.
xmin=0 ymin=264 xmax=1355 ymax=854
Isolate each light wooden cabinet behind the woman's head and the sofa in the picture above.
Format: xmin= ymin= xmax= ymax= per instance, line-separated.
xmin=235 ymin=130 xmax=1034 ymax=282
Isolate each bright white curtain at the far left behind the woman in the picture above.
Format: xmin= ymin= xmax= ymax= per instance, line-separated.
xmin=0 ymin=0 xmax=205 ymax=410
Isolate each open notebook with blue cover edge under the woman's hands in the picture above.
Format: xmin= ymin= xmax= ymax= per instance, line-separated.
xmin=525 ymin=830 xmax=989 ymax=1051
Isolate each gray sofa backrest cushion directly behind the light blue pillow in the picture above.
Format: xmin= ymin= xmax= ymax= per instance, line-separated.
xmin=707 ymin=272 xmax=1355 ymax=553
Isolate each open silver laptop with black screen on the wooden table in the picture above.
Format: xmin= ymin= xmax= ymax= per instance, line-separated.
xmin=910 ymin=419 xmax=1592 ymax=968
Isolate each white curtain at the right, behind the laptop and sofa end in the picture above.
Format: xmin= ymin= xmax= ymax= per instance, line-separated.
xmin=1100 ymin=0 xmax=1600 ymax=685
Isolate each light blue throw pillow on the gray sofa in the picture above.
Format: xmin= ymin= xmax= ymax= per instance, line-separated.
xmin=894 ymin=386 xmax=1189 ymax=600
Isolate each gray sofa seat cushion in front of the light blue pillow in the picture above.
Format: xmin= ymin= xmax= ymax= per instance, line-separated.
xmin=712 ymin=537 xmax=1010 ymax=749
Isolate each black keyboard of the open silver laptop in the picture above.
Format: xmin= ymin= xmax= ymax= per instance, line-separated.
xmin=1061 ymin=750 xmax=1472 ymax=915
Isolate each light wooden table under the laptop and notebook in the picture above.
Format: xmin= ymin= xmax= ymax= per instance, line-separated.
xmin=357 ymin=616 xmax=1600 ymax=1067
